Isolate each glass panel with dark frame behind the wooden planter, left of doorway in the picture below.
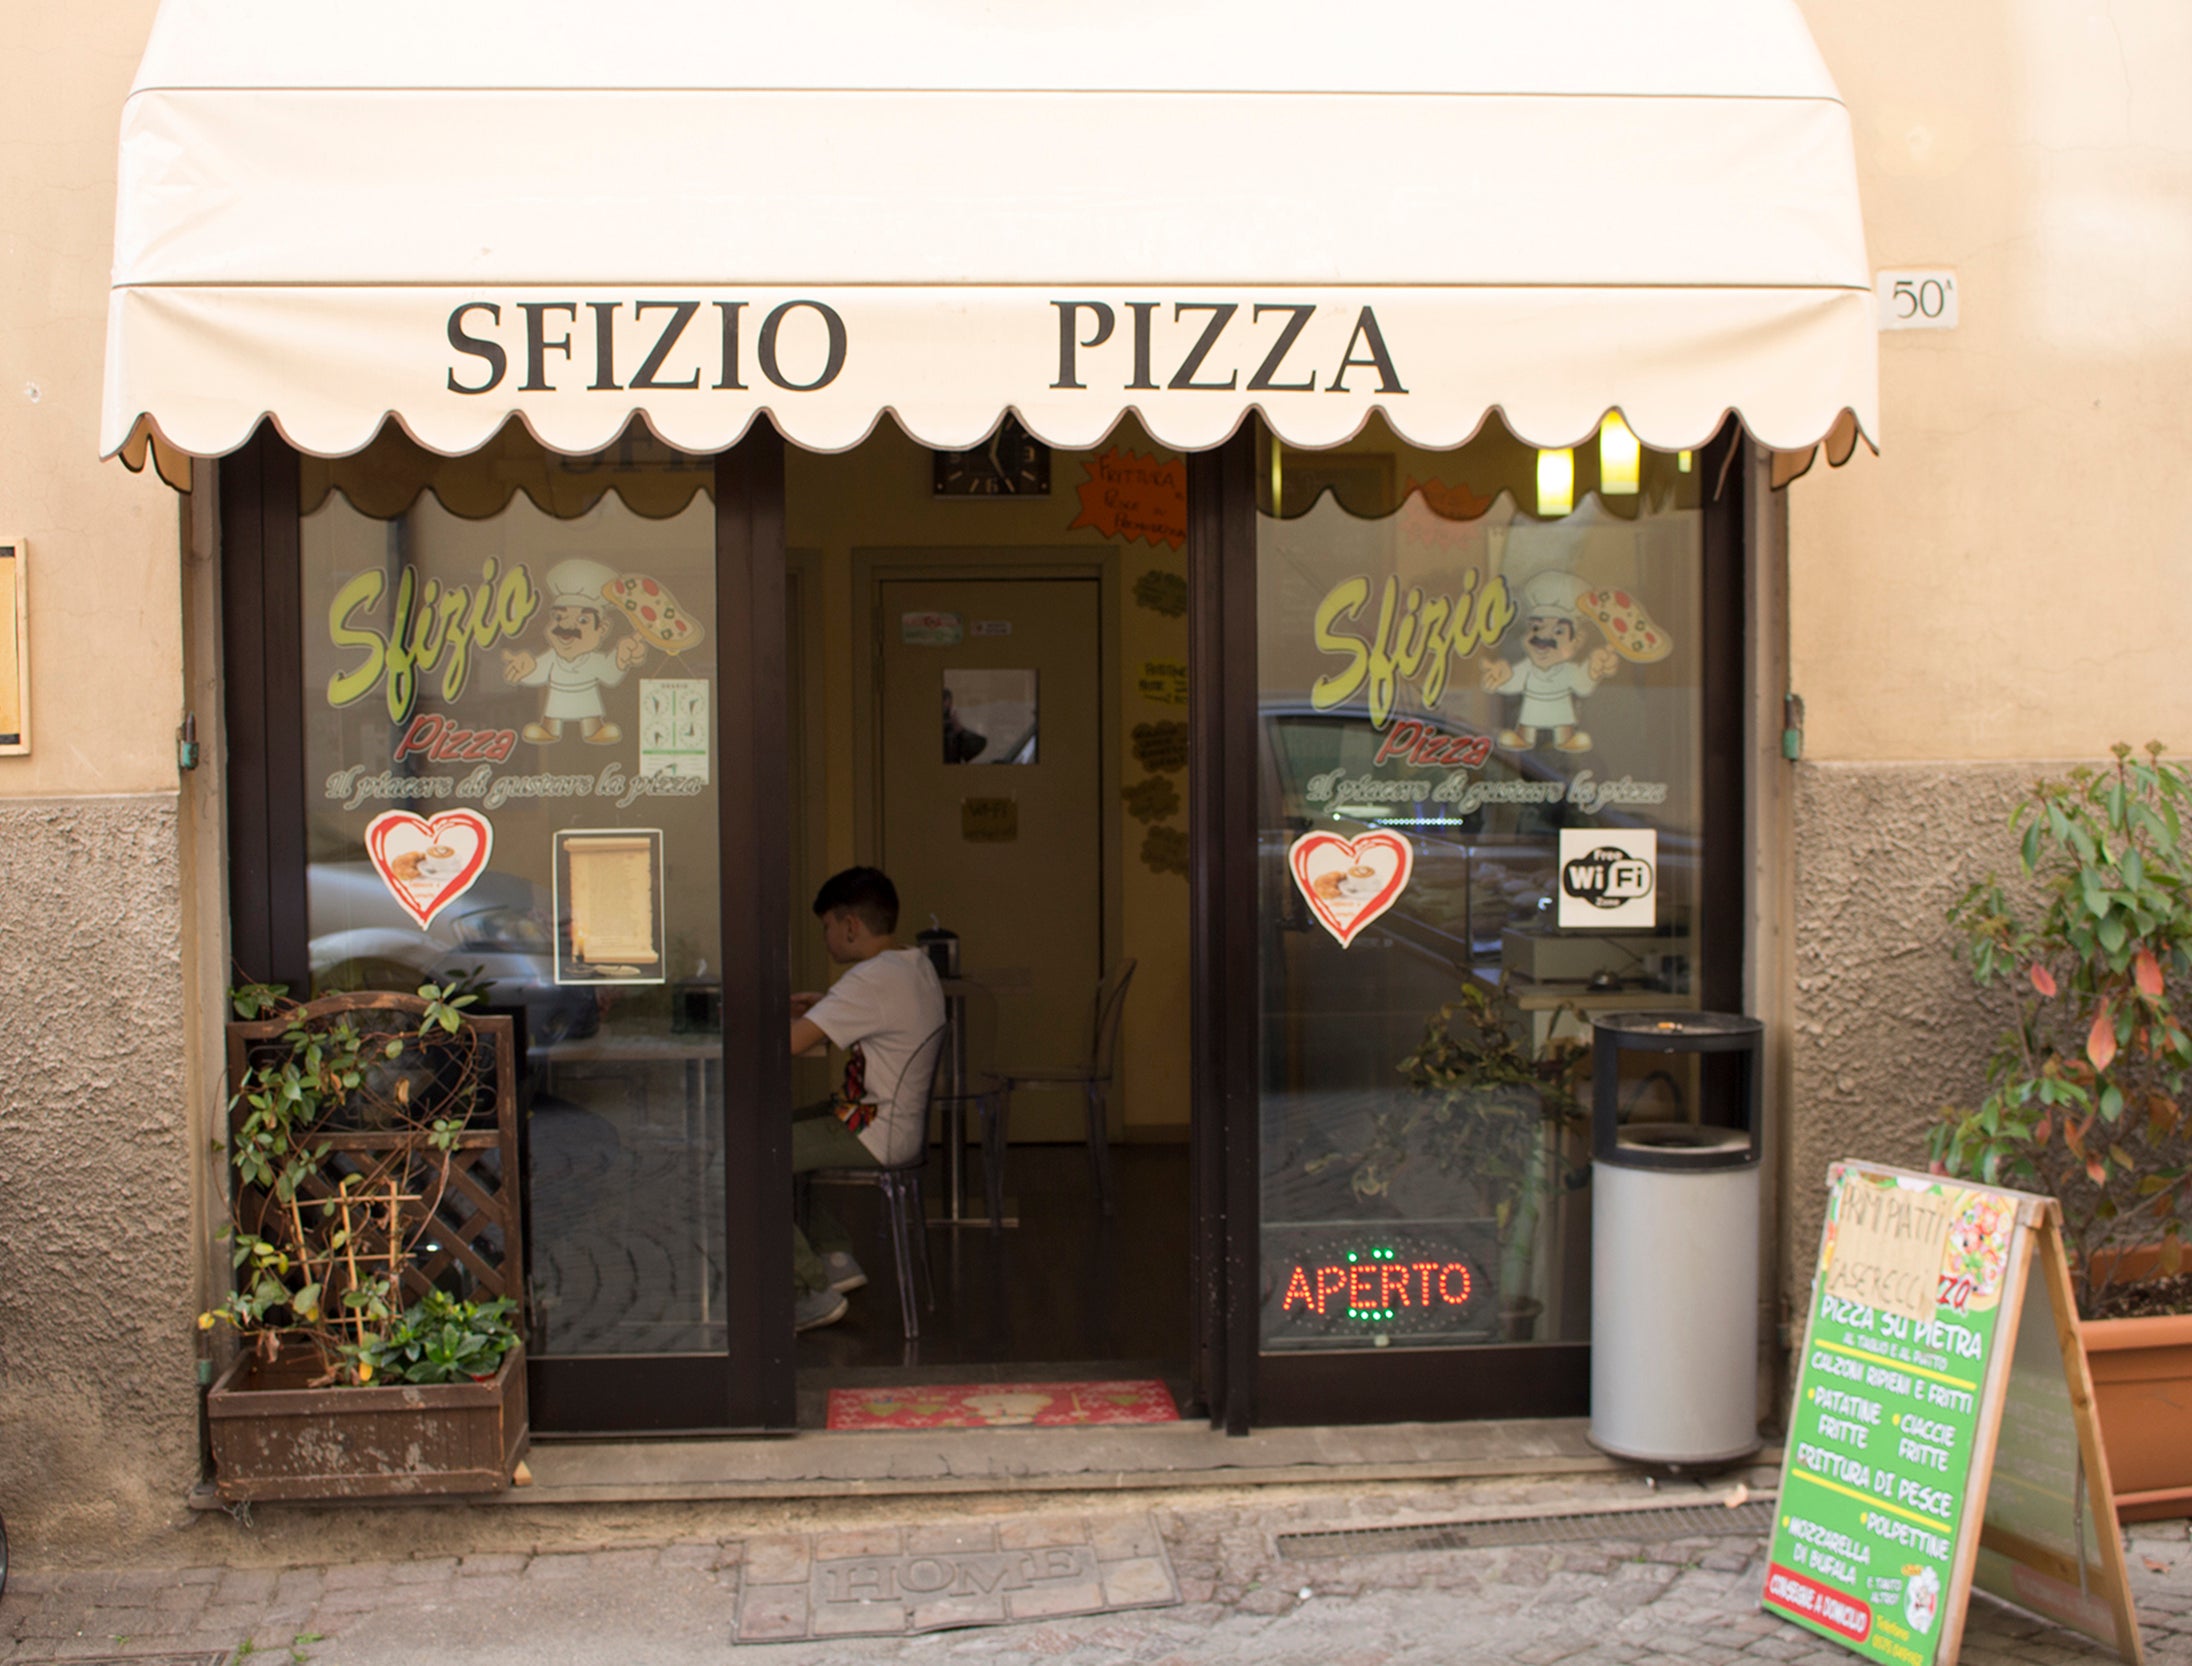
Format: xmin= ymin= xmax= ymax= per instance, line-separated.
xmin=249 ymin=432 xmax=791 ymax=1434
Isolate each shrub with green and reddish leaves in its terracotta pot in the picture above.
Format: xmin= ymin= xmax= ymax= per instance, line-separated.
xmin=1931 ymin=743 xmax=2192 ymax=1521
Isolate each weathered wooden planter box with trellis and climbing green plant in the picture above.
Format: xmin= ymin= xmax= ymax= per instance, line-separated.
xmin=199 ymin=984 xmax=528 ymax=1502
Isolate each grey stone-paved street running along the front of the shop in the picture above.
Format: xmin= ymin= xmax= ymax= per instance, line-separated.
xmin=0 ymin=1475 xmax=2192 ymax=1666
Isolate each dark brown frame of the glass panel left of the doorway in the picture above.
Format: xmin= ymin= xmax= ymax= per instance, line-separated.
xmin=219 ymin=421 xmax=796 ymax=1434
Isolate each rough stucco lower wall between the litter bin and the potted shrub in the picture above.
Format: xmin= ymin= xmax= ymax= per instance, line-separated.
xmin=1782 ymin=763 xmax=2067 ymax=1315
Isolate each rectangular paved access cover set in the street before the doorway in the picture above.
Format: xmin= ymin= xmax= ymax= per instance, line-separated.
xmin=734 ymin=1515 xmax=1179 ymax=1642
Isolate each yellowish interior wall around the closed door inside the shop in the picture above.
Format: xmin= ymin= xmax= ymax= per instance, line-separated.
xmin=785 ymin=421 xmax=1188 ymax=1129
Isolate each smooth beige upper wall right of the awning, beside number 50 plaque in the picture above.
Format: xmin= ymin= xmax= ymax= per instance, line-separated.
xmin=1791 ymin=0 xmax=2192 ymax=761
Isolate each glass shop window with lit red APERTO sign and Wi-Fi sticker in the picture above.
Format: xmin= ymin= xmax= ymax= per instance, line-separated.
xmin=1256 ymin=419 xmax=1703 ymax=1353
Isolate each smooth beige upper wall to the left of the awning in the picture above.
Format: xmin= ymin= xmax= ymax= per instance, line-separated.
xmin=0 ymin=0 xmax=182 ymax=796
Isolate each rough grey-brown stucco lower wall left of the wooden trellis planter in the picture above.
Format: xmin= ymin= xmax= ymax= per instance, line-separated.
xmin=0 ymin=794 xmax=197 ymax=1556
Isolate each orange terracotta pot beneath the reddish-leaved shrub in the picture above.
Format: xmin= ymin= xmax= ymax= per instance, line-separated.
xmin=2078 ymin=1313 xmax=2192 ymax=1521
